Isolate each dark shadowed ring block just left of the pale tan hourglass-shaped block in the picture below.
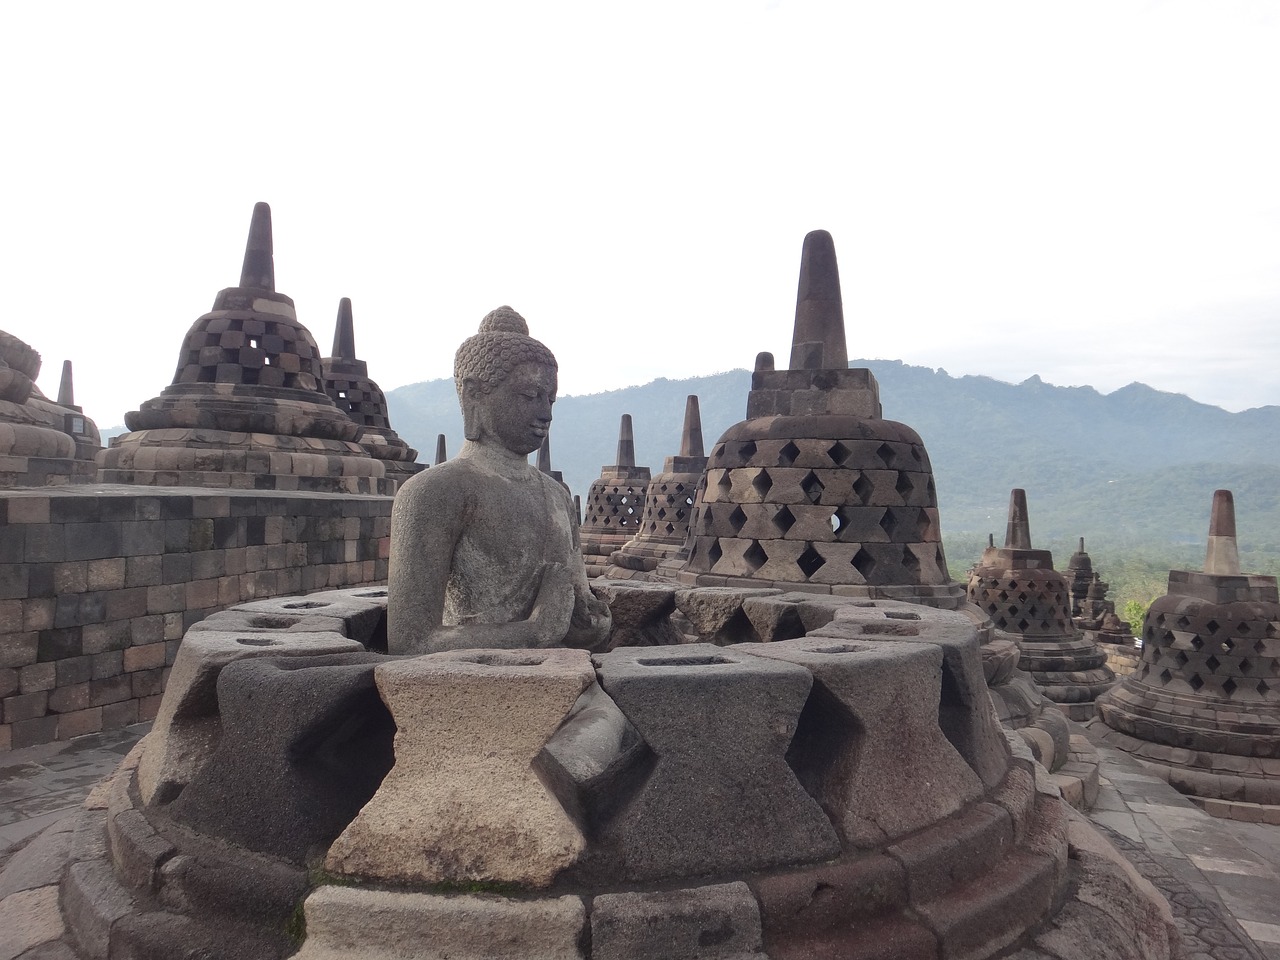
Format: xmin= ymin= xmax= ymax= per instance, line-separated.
xmin=169 ymin=653 xmax=396 ymax=863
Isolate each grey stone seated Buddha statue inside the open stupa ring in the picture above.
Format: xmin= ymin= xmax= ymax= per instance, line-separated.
xmin=388 ymin=306 xmax=611 ymax=654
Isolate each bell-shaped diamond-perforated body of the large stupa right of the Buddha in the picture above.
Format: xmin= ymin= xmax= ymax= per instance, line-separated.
xmin=681 ymin=415 xmax=950 ymax=595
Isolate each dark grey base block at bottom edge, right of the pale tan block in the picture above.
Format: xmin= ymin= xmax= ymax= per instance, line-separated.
xmin=591 ymin=882 xmax=765 ymax=960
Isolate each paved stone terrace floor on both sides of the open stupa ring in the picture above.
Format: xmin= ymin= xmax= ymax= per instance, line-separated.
xmin=0 ymin=723 xmax=1280 ymax=960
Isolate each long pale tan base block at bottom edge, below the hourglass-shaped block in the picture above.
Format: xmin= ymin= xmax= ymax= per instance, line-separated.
xmin=296 ymin=887 xmax=586 ymax=960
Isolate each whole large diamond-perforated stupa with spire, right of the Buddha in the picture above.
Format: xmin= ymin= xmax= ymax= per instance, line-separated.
xmin=680 ymin=230 xmax=963 ymax=607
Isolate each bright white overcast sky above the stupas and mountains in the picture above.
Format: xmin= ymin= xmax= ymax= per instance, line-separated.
xmin=0 ymin=0 xmax=1280 ymax=428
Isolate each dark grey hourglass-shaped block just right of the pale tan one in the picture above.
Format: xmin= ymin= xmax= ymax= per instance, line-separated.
xmin=588 ymin=644 xmax=840 ymax=882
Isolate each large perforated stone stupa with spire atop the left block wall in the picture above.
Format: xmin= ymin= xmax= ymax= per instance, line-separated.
xmin=99 ymin=204 xmax=396 ymax=494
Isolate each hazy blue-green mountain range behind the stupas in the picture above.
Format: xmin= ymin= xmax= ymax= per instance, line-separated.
xmin=387 ymin=360 xmax=1280 ymax=560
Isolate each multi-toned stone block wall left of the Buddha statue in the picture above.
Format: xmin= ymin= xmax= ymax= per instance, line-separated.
xmin=0 ymin=485 xmax=392 ymax=750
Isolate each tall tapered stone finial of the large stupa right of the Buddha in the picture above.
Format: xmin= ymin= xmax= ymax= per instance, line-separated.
xmin=791 ymin=230 xmax=849 ymax=370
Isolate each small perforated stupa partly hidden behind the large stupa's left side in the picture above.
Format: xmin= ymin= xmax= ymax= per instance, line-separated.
xmin=605 ymin=396 xmax=707 ymax=580
